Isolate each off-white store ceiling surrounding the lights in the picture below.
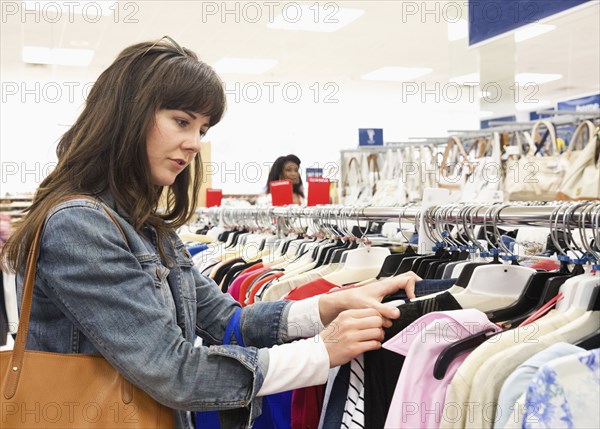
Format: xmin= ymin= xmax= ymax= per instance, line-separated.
xmin=0 ymin=0 xmax=600 ymax=106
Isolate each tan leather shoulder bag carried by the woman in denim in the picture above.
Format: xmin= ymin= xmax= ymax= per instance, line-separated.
xmin=0 ymin=196 xmax=175 ymax=429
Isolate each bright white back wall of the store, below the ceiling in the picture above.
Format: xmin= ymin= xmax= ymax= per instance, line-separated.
xmin=0 ymin=74 xmax=479 ymax=193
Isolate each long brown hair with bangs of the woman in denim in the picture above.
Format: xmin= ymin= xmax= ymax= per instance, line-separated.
xmin=3 ymin=39 xmax=225 ymax=271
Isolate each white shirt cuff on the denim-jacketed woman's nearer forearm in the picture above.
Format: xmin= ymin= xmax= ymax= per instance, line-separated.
xmin=256 ymin=335 xmax=329 ymax=396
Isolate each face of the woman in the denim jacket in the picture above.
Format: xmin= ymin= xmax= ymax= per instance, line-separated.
xmin=146 ymin=109 xmax=210 ymax=186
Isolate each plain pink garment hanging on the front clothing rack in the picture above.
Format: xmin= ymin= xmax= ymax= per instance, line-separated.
xmin=383 ymin=309 xmax=500 ymax=429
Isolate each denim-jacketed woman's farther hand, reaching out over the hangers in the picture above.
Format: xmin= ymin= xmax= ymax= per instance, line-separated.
xmin=319 ymin=271 xmax=421 ymax=327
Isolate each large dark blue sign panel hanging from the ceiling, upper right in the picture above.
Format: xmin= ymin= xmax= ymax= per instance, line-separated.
xmin=468 ymin=0 xmax=590 ymax=45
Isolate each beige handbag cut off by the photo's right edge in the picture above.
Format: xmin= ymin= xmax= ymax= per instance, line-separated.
xmin=556 ymin=121 xmax=600 ymax=200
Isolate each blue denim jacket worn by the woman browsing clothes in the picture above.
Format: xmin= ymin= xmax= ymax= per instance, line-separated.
xmin=17 ymin=197 xmax=294 ymax=428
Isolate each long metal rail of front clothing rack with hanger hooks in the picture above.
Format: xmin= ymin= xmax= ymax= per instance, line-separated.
xmin=198 ymin=201 xmax=600 ymax=258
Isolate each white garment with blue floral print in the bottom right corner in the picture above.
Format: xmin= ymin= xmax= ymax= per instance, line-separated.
xmin=523 ymin=349 xmax=600 ymax=429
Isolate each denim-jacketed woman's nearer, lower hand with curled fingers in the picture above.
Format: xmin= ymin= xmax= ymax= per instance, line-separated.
xmin=319 ymin=308 xmax=384 ymax=368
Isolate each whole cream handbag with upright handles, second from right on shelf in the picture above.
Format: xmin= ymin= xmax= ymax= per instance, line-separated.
xmin=504 ymin=120 xmax=565 ymax=201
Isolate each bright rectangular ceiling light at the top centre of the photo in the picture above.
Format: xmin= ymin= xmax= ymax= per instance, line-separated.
xmin=267 ymin=2 xmax=365 ymax=33
